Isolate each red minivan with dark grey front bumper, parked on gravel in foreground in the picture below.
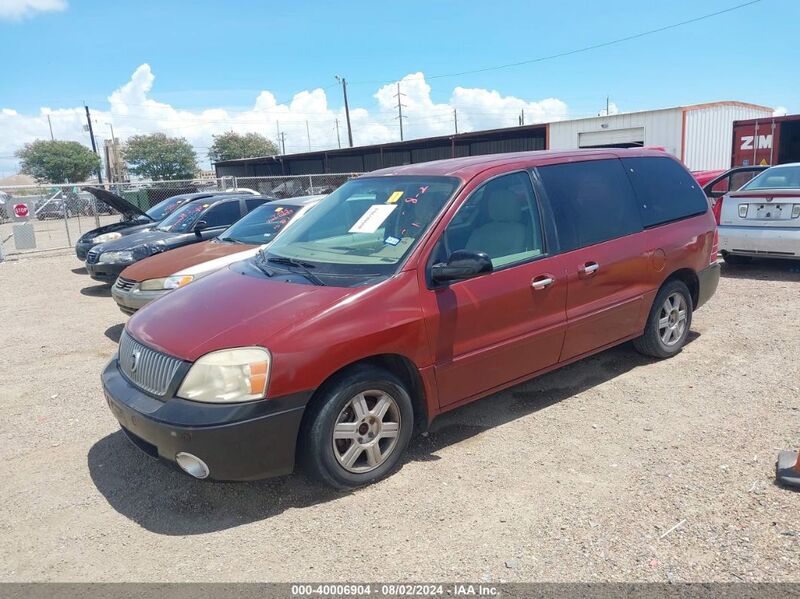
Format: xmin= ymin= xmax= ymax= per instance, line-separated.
xmin=102 ymin=149 xmax=719 ymax=488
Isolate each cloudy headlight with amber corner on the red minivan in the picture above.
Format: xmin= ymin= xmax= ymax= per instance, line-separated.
xmin=178 ymin=347 xmax=272 ymax=403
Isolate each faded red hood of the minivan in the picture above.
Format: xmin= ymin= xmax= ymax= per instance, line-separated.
xmin=127 ymin=268 xmax=354 ymax=362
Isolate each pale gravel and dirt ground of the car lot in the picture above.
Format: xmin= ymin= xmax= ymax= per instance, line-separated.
xmin=0 ymin=253 xmax=800 ymax=582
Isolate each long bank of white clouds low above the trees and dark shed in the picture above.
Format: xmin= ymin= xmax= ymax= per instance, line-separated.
xmin=0 ymin=64 xmax=567 ymax=175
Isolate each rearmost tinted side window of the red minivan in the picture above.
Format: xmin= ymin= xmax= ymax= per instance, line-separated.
xmin=622 ymin=157 xmax=708 ymax=227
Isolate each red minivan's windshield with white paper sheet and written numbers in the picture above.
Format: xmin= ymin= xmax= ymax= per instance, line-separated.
xmin=265 ymin=176 xmax=460 ymax=276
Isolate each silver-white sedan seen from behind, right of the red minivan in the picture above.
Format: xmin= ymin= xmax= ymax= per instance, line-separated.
xmin=715 ymin=162 xmax=800 ymax=264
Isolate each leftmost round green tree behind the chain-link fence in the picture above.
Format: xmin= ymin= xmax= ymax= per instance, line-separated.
xmin=16 ymin=139 xmax=100 ymax=183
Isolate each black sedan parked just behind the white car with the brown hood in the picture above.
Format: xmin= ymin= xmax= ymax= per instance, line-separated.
xmin=85 ymin=194 xmax=274 ymax=285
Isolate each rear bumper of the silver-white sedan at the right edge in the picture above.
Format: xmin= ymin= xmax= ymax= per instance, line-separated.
xmin=719 ymin=225 xmax=800 ymax=258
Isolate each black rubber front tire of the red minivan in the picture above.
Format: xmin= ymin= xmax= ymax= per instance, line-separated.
xmin=297 ymin=365 xmax=414 ymax=489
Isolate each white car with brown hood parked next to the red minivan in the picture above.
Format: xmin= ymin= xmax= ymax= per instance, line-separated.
xmin=111 ymin=195 xmax=325 ymax=314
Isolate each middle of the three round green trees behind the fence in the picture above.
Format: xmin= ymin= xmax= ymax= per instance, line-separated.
xmin=122 ymin=133 xmax=198 ymax=181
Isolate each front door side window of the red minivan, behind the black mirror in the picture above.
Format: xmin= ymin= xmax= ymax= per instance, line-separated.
xmin=436 ymin=172 xmax=544 ymax=270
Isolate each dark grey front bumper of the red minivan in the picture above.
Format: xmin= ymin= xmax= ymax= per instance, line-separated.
xmin=101 ymin=358 xmax=311 ymax=480
